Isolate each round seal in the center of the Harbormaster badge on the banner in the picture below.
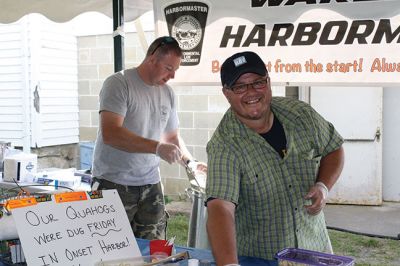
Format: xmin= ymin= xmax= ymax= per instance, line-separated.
xmin=172 ymin=15 xmax=203 ymax=50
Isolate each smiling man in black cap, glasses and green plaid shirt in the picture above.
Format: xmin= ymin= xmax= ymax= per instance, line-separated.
xmin=206 ymin=52 xmax=344 ymax=265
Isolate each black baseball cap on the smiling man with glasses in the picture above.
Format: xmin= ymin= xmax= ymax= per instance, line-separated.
xmin=221 ymin=51 xmax=268 ymax=87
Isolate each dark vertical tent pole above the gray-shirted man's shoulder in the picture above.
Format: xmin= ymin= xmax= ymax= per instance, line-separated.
xmin=113 ymin=0 xmax=125 ymax=72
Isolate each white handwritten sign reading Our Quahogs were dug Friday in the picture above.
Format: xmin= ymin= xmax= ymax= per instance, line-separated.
xmin=12 ymin=190 xmax=141 ymax=266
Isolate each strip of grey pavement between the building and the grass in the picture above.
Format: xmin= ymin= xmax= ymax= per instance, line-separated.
xmin=167 ymin=201 xmax=400 ymax=239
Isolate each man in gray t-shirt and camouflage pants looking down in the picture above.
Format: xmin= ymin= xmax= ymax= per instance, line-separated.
xmin=92 ymin=36 xmax=207 ymax=239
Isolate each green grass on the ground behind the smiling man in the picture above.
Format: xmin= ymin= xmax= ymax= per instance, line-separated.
xmin=167 ymin=214 xmax=400 ymax=266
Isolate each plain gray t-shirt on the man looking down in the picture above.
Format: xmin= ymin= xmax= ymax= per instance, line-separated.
xmin=93 ymin=68 xmax=179 ymax=186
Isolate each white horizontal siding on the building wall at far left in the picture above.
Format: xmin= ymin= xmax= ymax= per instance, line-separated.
xmin=0 ymin=15 xmax=79 ymax=147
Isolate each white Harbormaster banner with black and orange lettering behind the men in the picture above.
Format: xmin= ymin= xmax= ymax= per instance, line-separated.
xmin=154 ymin=0 xmax=400 ymax=86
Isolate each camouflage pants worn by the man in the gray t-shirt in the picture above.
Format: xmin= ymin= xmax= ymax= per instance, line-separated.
xmin=92 ymin=178 xmax=169 ymax=240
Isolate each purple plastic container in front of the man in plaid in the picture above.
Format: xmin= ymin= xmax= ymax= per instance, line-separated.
xmin=276 ymin=248 xmax=354 ymax=266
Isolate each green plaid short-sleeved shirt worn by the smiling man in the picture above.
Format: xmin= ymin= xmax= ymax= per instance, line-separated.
xmin=206 ymin=97 xmax=343 ymax=260
